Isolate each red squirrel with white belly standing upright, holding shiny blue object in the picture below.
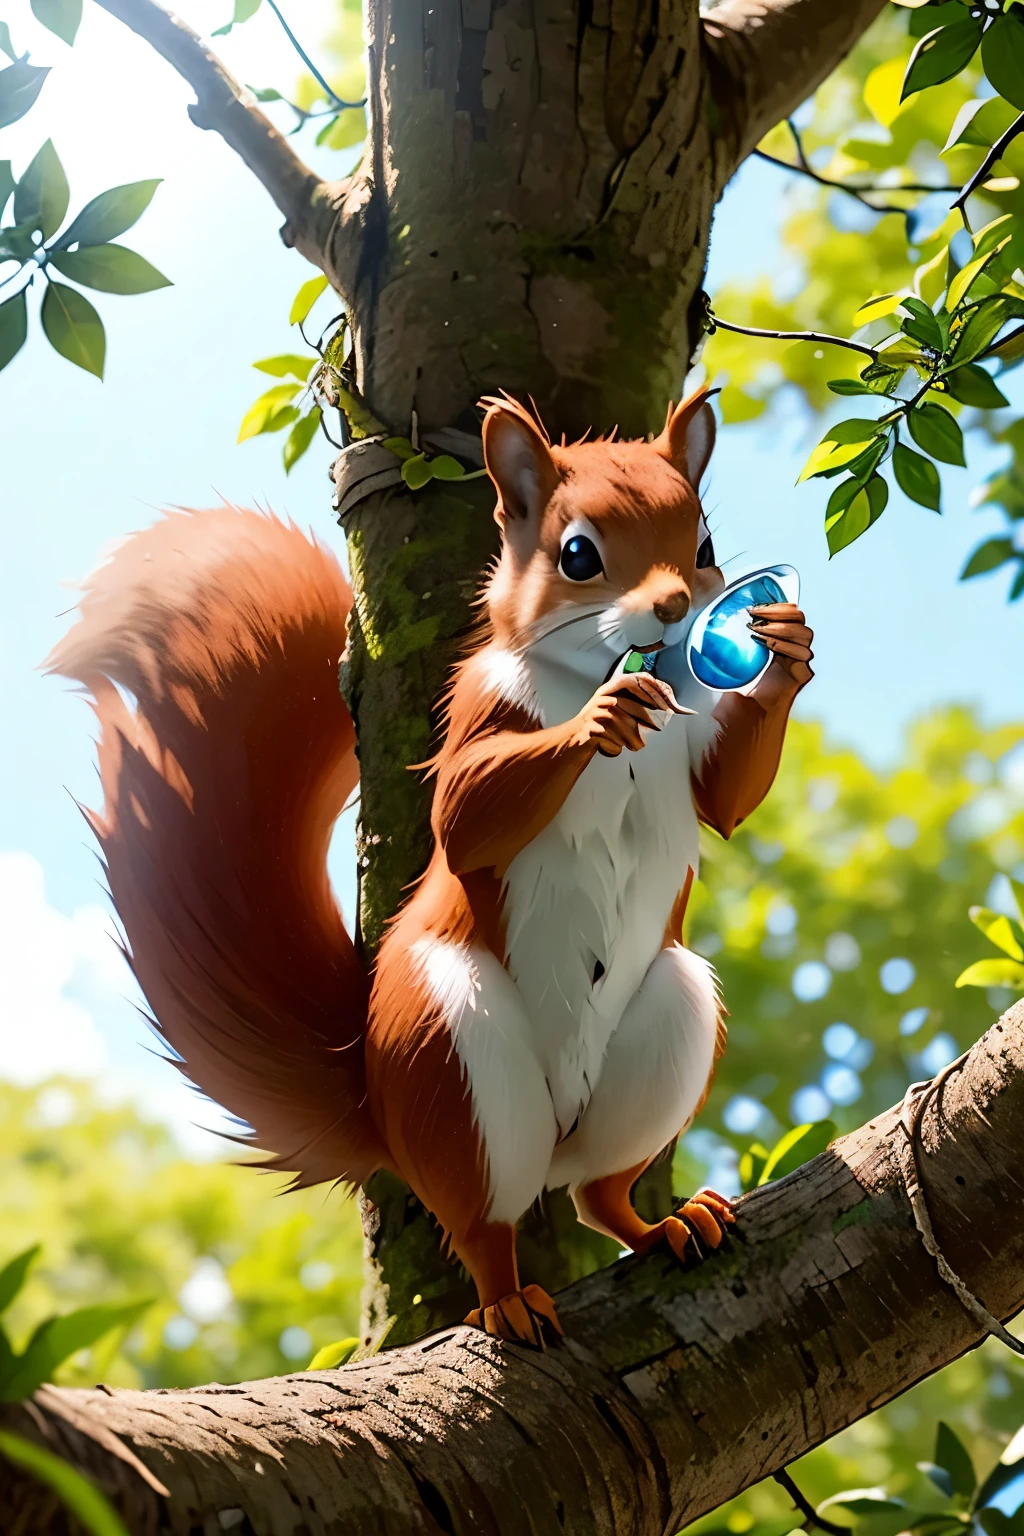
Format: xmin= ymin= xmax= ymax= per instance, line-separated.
xmin=48 ymin=380 xmax=812 ymax=1346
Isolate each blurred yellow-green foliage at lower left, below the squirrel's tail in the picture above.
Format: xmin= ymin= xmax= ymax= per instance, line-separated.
xmin=0 ymin=1066 xmax=362 ymax=1387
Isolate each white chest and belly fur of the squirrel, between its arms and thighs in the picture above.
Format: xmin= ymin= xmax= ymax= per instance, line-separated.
xmin=505 ymin=626 xmax=714 ymax=1134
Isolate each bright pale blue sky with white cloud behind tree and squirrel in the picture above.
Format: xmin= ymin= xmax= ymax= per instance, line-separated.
xmin=0 ymin=0 xmax=1024 ymax=1146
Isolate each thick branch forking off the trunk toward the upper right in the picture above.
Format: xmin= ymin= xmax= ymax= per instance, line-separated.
xmin=703 ymin=0 xmax=884 ymax=169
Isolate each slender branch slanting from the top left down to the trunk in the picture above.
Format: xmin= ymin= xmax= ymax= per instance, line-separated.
xmin=89 ymin=0 xmax=338 ymax=275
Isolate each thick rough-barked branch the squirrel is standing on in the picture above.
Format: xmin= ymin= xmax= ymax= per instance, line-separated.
xmin=0 ymin=1001 xmax=1024 ymax=1536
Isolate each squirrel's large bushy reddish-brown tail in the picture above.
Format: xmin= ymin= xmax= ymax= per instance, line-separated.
xmin=46 ymin=505 xmax=385 ymax=1184
